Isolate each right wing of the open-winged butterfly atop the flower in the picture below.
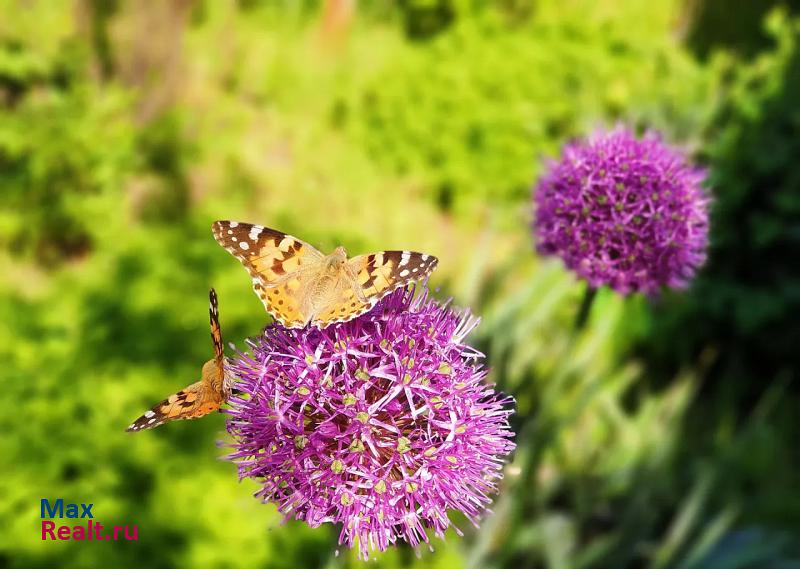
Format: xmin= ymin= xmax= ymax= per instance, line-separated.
xmin=314 ymin=251 xmax=439 ymax=328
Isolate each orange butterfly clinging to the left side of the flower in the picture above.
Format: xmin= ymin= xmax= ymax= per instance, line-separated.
xmin=127 ymin=288 xmax=231 ymax=431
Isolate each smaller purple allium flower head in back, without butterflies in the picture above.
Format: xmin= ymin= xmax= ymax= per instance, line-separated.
xmin=534 ymin=127 xmax=709 ymax=295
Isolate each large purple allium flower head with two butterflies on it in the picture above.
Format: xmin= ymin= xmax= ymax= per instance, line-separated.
xmin=228 ymin=290 xmax=514 ymax=558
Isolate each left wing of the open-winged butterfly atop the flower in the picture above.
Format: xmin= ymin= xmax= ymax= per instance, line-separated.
xmin=212 ymin=221 xmax=325 ymax=328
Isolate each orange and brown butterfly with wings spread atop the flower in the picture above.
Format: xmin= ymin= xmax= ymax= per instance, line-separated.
xmin=212 ymin=221 xmax=438 ymax=328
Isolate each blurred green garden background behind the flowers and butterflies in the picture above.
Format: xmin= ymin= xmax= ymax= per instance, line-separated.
xmin=0 ymin=0 xmax=800 ymax=569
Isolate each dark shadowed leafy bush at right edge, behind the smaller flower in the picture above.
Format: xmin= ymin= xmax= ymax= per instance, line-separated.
xmin=654 ymin=15 xmax=800 ymax=401
